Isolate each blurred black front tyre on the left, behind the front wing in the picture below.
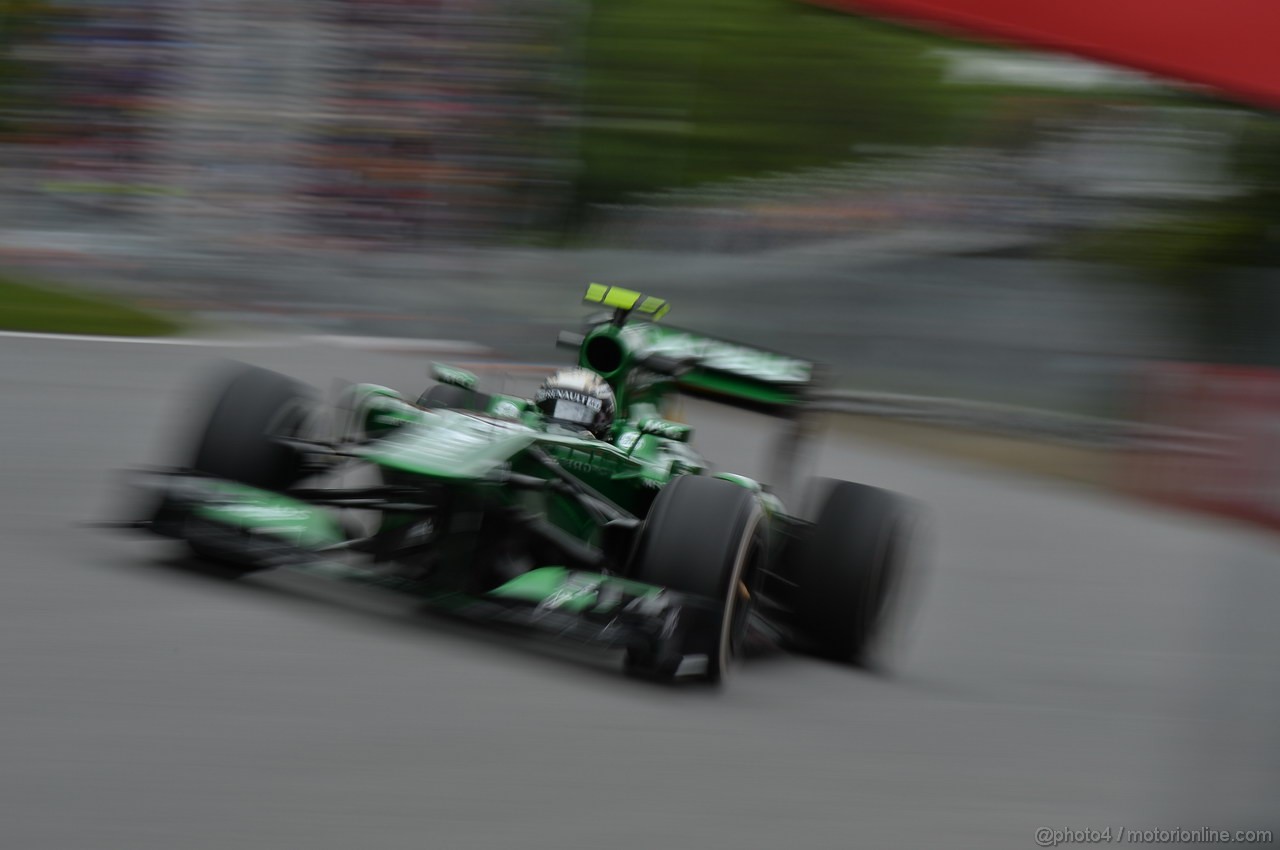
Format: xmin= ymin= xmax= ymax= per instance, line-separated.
xmin=188 ymin=364 xmax=315 ymax=576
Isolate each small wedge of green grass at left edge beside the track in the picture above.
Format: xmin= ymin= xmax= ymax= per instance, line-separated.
xmin=0 ymin=273 xmax=178 ymax=337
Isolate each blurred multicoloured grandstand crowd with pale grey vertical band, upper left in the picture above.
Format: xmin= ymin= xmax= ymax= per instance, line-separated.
xmin=5 ymin=0 xmax=572 ymax=243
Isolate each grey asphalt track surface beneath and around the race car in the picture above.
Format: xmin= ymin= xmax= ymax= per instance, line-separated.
xmin=0 ymin=338 xmax=1280 ymax=850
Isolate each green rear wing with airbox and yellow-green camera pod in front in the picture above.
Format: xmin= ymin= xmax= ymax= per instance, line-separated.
xmin=576 ymin=284 xmax=817 ymax=415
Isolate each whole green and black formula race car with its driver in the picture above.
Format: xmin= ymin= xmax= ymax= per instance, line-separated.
xmin=115 ymin=284 xmax=910 ymax=681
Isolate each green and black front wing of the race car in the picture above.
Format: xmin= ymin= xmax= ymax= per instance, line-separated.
xmin=123 ymin=470 xmax=742 ymax=677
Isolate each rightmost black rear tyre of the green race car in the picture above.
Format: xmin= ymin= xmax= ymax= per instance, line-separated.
xmin=796 ymin=481 xmax=910 ymax=667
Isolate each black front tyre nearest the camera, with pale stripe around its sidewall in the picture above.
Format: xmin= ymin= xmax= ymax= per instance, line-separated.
xmin=627 ymin=475 xmax=765 ymax=682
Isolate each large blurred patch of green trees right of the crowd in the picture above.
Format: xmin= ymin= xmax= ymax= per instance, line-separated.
xmin=576 ymin=0 xmax=965 ymax=209
